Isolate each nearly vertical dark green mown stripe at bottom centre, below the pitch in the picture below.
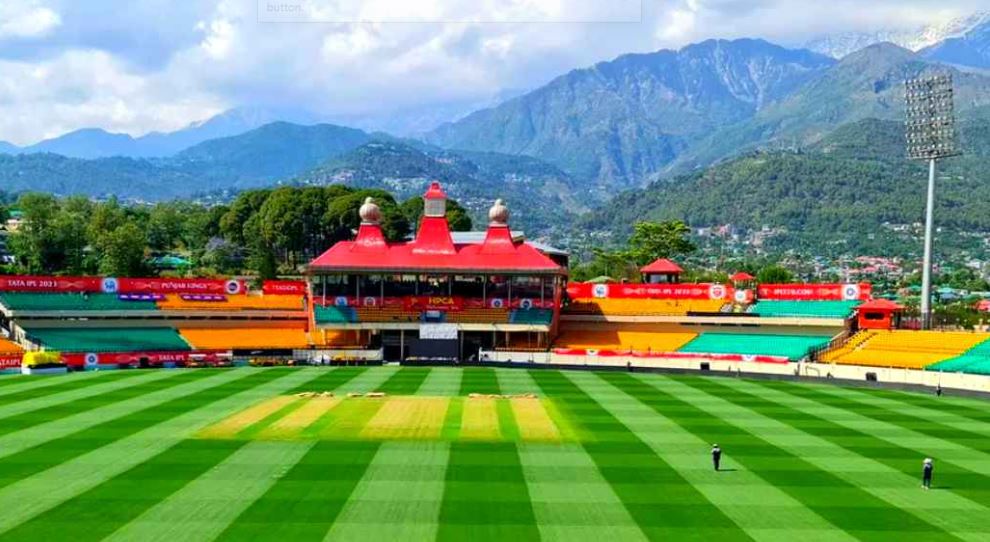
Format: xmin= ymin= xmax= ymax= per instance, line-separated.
xmin=436 ymin=442 xmax=540 ymax=541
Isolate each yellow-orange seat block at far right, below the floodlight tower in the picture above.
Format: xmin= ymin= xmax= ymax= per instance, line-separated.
xmin=821 ymin=330 xmax=990 ymax=369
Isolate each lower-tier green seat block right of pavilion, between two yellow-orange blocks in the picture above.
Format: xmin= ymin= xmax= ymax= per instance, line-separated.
xmin=678 ymin=333 xmax=831 ymax=360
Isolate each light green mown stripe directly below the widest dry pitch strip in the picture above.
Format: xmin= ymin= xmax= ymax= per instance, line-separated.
xmin=324 ymin=442 xmax=450 ymax=542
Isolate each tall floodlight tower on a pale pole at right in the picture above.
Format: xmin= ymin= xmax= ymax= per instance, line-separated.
xmin=904 ymin=74 xmax=960 ymax=329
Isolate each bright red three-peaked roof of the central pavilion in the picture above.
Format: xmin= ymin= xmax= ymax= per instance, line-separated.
xmin=309 ymin=183 xmax=564 ymax=274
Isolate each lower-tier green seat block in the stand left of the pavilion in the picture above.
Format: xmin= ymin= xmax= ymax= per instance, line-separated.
xmin=26 ymin=328 xmax=190 ymax=353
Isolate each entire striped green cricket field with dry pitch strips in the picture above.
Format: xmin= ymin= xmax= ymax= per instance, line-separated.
xmin=0 ymin=367 xmax=990 ymax=542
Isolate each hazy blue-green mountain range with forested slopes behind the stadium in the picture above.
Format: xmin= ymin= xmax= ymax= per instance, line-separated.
xmin=0 ymin=14 xmax=990 ymax=253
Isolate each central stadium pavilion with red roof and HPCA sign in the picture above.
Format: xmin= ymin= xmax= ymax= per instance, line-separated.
xmin=308 ymin=182 xmax=567 ymax=361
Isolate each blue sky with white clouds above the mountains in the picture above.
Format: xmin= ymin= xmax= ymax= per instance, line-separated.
xmin=0 ymin=0 xmax=985 ymax=145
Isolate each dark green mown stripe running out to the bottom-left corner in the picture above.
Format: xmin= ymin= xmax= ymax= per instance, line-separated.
xmin=0 ymin=440 xmax=244 ymax=542
